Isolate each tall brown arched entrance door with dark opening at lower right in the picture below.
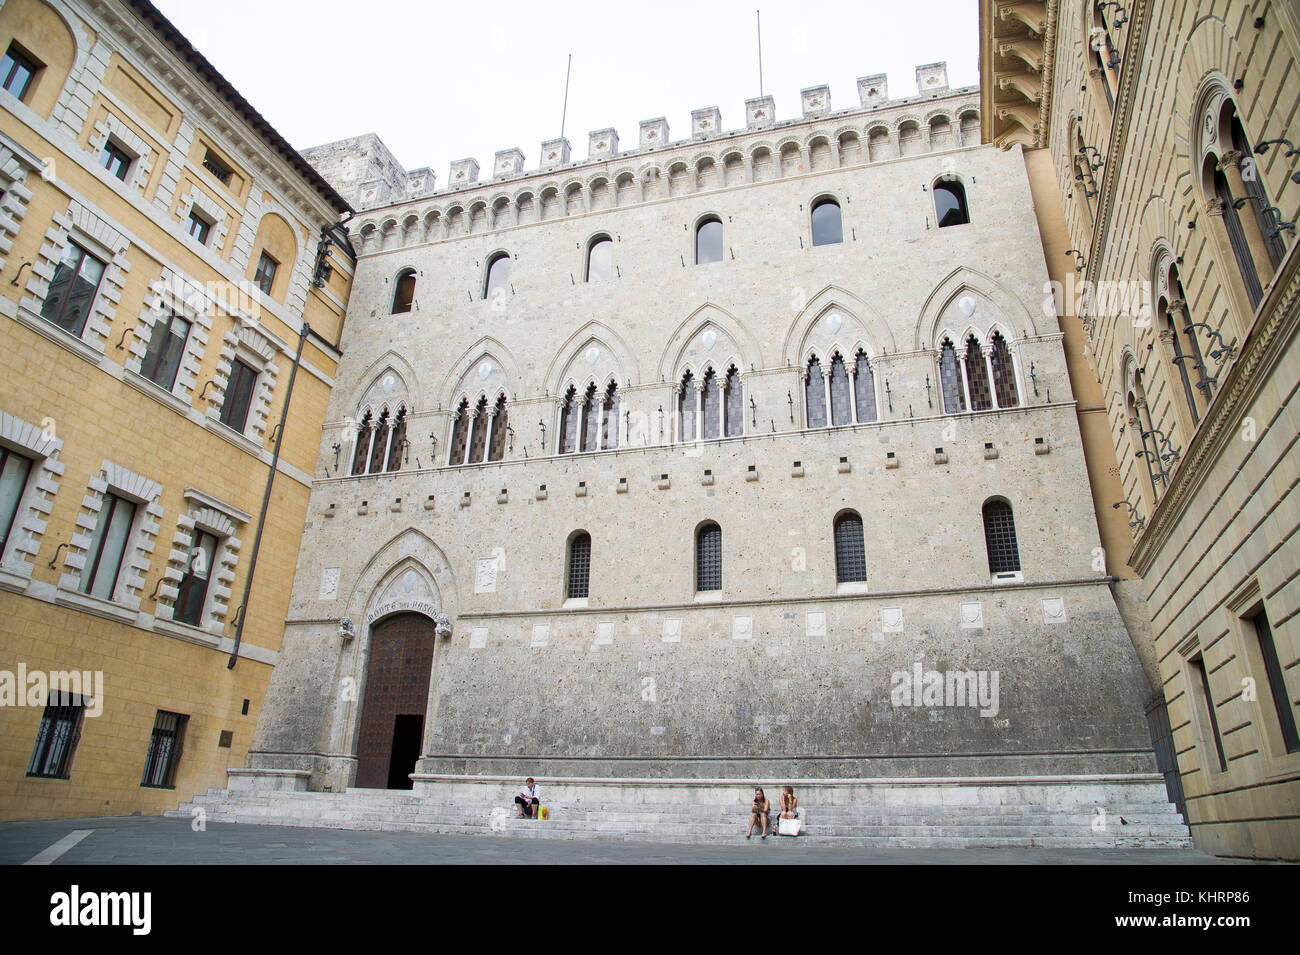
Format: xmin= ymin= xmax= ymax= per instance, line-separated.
xmin=356 ymin=613 xmax=434 ymax=789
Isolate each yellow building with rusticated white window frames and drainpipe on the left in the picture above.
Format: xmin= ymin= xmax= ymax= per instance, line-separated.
xmin=0 ymin=0 xmax=352 ymax=819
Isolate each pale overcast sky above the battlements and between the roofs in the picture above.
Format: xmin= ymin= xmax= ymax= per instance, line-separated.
xmin=153 ymin=0 xmax=979 ymax=180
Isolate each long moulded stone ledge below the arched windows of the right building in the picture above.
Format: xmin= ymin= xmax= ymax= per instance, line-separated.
xmin=1128 ymin=244 xmax=1300 ymax=576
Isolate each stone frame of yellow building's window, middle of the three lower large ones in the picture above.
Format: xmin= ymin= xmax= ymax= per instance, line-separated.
xmin=56 ymin=457 xmax=164 ymax=622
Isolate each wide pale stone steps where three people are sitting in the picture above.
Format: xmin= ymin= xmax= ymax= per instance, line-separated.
xmin=166 ymin=773 xmax=1192 ymax=848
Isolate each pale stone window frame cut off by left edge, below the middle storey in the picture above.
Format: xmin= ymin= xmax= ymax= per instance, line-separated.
xmin=0 ymin=411 xmax=66 ymax=590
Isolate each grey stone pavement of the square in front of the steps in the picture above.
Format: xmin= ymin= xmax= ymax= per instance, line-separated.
xmin=0 ymin=816 xmax=1223 ymax=865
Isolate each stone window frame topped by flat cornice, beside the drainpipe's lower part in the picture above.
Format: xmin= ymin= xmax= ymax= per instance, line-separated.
xmin=153 ymin=487 xmax=252 ymax=638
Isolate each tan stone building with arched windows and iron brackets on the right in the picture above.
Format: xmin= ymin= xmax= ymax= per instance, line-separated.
xmin=980 ymin=0 xmax=1300 ymax=859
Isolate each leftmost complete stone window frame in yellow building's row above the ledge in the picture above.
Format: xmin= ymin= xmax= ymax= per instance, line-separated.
xmin=18 ymin=199 xmax=131 ymax=364
